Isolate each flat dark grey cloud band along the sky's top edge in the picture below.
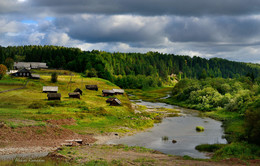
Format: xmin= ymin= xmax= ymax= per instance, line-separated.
xmin=28 ymin=0 xmax=260 ymax=16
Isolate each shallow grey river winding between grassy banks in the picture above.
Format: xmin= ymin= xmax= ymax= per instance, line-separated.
xmin=107 ymin=97 xmax=227 ymax=158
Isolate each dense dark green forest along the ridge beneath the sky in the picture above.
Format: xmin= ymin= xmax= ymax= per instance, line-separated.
xmin=0 ymin=46 xmax=260 ymax=89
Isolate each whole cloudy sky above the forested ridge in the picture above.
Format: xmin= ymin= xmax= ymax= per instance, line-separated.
xmin=0 ymin=0 xmax=260 ymax=63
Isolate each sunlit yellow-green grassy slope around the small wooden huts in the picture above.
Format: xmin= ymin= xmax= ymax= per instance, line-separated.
xmin=0 ymin=71 xmax=156 ymax=133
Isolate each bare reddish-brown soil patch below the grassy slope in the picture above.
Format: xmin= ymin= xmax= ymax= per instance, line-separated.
xmin=0 ymin=125 xmax=96 ymax=155
